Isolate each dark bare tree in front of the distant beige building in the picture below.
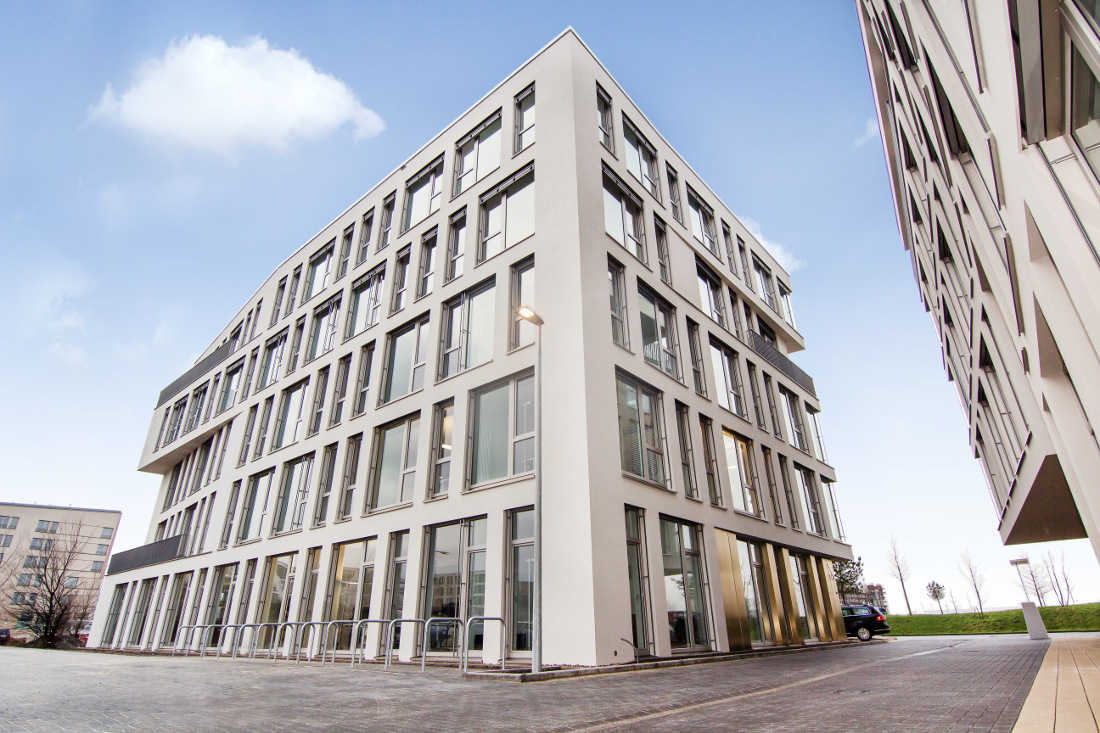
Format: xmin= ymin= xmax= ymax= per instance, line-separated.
xmin=0 ymin=522 xmax=94 ymax=647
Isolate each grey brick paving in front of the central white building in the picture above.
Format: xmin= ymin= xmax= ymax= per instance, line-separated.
xmin=0 ymin=636 xmax=1047 ymax=733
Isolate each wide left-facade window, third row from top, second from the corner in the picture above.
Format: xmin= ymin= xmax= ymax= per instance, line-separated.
xmin=438 ymin=281 xmax=496 ymax=380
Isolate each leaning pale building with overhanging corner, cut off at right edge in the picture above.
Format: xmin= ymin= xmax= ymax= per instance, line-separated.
xmin=856 ymin=0 xmax=1100 ymax=556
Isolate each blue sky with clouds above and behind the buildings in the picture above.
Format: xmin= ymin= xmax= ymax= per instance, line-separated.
xmin=0 ymin=0 xmax=1100 ymax=610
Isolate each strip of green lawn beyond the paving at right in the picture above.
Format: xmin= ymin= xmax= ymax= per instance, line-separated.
xmin=887 ymin=603 xmax=1100 ymax=636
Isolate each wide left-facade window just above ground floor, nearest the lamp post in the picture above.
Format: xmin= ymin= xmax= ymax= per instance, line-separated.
xmin=466 ymin=374 xmax=535 ymax=485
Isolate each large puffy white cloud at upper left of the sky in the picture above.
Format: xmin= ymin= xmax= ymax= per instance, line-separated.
xmin=90 ymin=35 xmax=385 ymax=155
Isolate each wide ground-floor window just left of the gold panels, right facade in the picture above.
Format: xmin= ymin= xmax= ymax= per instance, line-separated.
xmin=661 ymin=516 xmax=710 ymax=649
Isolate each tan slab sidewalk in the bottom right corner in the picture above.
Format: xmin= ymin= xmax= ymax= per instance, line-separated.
xmin=1013 ymin=633 xmax=1100 ymax=733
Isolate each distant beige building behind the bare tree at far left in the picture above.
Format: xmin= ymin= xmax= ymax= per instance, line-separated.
xmin=0 ymin=503 xmax=122 ymax=638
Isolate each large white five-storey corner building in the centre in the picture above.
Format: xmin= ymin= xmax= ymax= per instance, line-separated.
xmin=91 ymin=30 xmax=851 ymax=665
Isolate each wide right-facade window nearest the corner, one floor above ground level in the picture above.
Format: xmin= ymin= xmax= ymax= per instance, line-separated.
xmin=615 ymin=375 xmax=664 ymax=485
